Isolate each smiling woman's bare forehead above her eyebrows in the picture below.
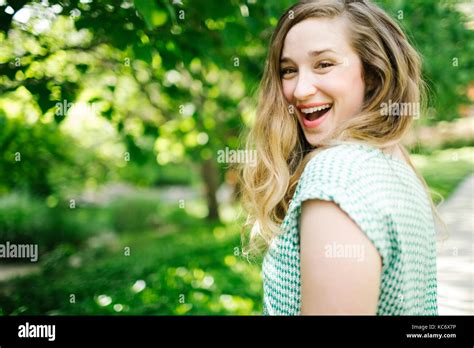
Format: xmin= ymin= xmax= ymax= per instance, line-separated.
xmin=282 ymin=17 xmax=351 ymax=60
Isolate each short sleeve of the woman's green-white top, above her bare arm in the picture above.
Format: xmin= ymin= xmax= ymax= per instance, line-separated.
xmin=283 ymin=147 xmax=396 ymax=268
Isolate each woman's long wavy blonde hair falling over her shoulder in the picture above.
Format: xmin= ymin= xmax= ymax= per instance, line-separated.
xmin=240 ymin=0 xmax=445 ymax=256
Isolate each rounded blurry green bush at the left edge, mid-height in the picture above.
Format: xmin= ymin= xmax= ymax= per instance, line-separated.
xmin=0 ymin=110 xmax=114 ymax=199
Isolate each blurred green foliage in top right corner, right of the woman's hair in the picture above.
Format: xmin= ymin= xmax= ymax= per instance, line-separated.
xmin=377 ymin=0 xmax=474 ymax=124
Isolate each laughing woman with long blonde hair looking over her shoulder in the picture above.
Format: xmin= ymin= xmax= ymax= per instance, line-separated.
xmin=242 ymin=0 xmax=439 ymax=315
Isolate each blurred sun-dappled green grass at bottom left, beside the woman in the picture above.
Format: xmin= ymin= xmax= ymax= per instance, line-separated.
xmin=0 ymin=207 xmax=262 ymax=315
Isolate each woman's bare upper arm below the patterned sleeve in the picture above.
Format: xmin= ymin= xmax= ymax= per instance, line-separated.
xmin=300 ymin=200 xmax=382 ymax=315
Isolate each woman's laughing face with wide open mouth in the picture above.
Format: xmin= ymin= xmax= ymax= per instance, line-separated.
xmin=280 ymin=18 xmax=365 ymax=146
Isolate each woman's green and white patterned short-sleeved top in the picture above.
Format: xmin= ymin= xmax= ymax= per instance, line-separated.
xmin=262 ymin=143 xmax=438 ymax=315
